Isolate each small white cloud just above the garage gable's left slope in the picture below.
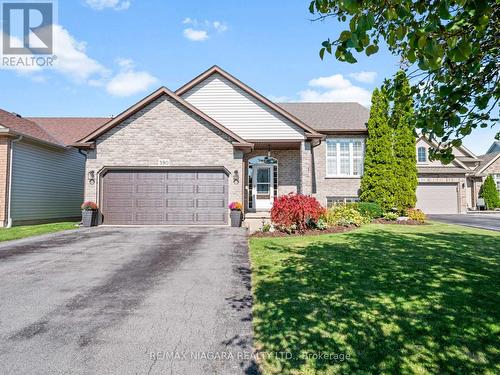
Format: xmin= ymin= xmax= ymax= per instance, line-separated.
xmin=106 ymin=59 xmax=158 ymax=96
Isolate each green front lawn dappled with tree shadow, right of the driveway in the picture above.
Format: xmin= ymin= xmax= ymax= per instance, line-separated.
xmin=250 ymin=223 xmax=500 ymax=374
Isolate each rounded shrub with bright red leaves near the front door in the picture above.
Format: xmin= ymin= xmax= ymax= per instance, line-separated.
xmin=271 ymin=193 xmax=325 ymax=232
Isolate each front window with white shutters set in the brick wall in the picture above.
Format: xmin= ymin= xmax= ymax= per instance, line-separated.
xmin=326 ymin=138 xmax=365 ymax=177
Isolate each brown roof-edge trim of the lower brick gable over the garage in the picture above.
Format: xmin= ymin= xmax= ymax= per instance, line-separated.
xmin=74 ymin=86 xmax=252 ymax=147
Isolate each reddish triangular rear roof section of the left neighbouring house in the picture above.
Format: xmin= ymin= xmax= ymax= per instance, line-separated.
xmin=27 ymin=117 xmax=110 ymax=145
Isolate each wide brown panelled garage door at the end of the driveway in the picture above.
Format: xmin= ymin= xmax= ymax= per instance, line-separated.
xmin=102 ymin=170 xmax=228 ymax=225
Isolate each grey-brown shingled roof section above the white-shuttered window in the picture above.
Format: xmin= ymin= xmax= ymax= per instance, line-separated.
xmin=278 ymin=102 xmax=370 ymax=132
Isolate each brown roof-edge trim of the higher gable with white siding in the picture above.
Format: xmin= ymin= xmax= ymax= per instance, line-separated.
xmin=175 ymin=65 xmax=323 ymax=138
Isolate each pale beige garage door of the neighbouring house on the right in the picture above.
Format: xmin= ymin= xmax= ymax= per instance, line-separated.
xmin=417 ymin=183 xmax=458 ymax=214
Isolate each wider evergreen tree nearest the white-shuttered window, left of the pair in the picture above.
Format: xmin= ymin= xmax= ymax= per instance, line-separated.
xmin=360 ymin=89 xmax=396 ymax=210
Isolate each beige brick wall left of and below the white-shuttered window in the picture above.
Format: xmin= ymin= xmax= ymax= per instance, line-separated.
xmin=312 ymin=141 xmax=361 ymax=206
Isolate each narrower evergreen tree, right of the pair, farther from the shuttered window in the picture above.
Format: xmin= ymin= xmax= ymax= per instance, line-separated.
xmin=390 ymin=71 xmax=418 ymax=212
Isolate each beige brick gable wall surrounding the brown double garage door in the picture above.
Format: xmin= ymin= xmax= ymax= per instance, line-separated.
xmin=85 ymin=96 xmax=243 ymax=222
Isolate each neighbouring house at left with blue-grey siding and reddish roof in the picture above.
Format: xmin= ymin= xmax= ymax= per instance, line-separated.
xmin=0 ymin=110 xmax=109 ymax=226
